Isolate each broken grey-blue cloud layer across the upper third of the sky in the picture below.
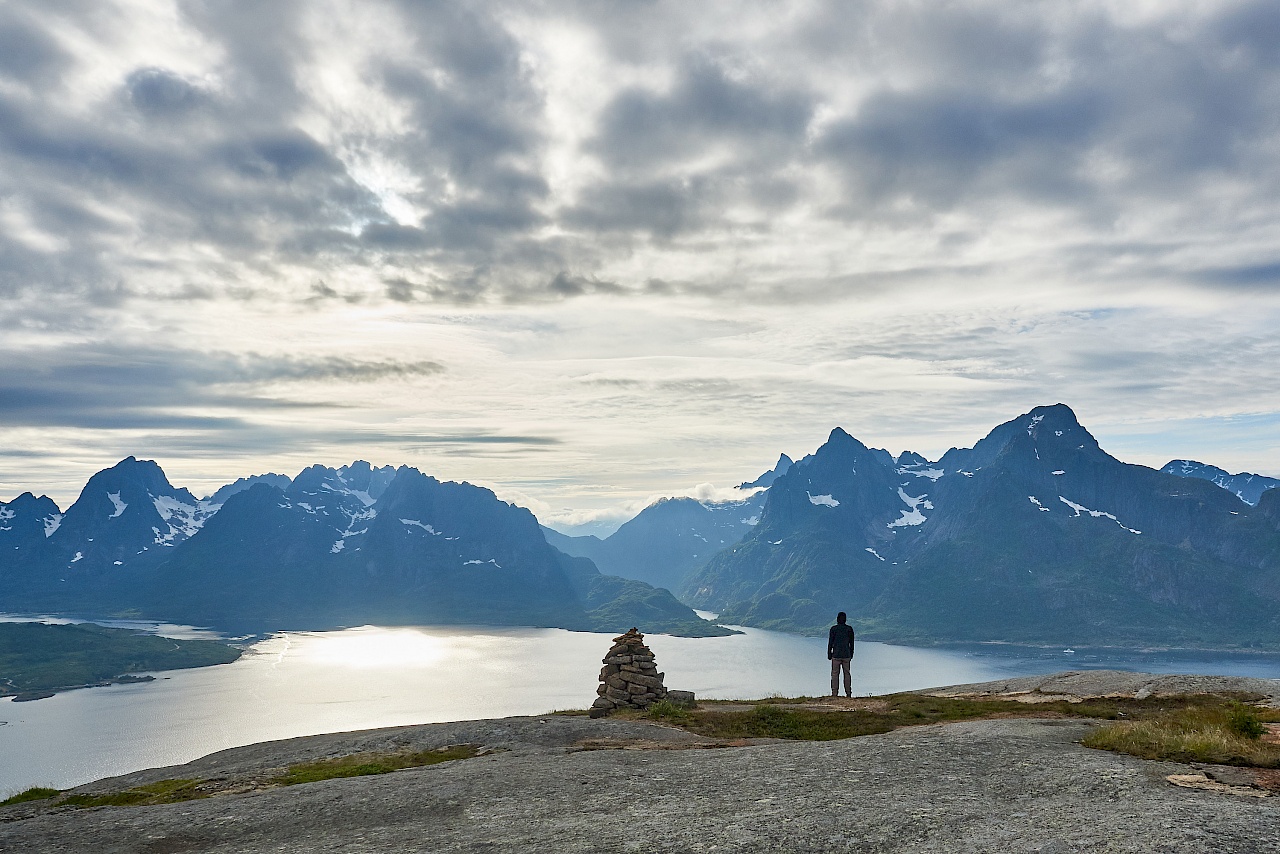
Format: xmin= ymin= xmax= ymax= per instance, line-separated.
xmin=0 ymin=0 xmax=1280 ymax=317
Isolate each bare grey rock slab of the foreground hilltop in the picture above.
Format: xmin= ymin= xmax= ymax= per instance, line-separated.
xmin=0 ymin=673 xmax=1280 ymax=854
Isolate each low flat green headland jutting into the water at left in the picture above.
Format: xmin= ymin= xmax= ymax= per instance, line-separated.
xmin=0 ymin=622 xmax=242 ymax=697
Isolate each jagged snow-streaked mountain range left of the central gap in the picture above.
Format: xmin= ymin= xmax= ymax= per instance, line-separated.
xmin=0 ymin=457 xmax=727 ymax=635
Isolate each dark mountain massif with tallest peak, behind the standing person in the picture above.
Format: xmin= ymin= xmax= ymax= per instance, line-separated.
xmin=684 ymin=405 xmax=1280 ymax=648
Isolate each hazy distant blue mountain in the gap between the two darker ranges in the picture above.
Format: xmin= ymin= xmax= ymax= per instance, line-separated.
xmin=543 ymin=486 xmax=762 ymax=590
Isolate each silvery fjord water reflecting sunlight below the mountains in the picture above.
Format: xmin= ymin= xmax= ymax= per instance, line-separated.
xmin=0 ymin=624 xmax=1280 ymax=796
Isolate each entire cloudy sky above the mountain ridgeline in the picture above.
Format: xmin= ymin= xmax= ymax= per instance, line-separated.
xmin=0 ymin=0 xmax=1280 ymax=531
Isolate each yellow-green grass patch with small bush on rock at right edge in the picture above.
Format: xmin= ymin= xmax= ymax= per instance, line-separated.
xmin=1083 ymin=703 xmax=1280 ymax=768
